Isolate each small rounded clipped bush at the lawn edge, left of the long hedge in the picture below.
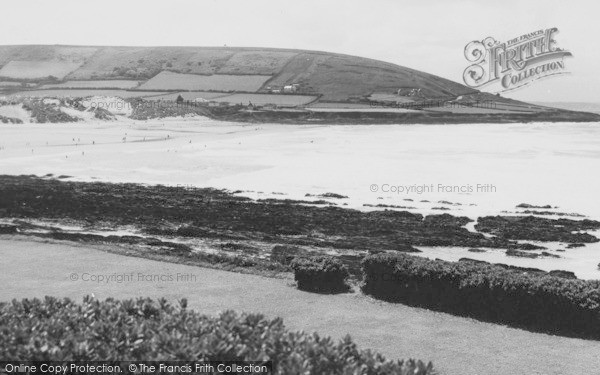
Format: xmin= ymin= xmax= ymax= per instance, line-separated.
xmin=291 ymin=256 xmax=348 ymax=293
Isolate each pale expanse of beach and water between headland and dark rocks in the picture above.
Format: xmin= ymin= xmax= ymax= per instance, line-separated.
xmin=0 ymin=118 xmax=600 ymax=279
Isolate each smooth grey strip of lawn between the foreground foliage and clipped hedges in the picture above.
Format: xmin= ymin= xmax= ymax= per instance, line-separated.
xmin=0 ymin=237 xmax=600 ymax=375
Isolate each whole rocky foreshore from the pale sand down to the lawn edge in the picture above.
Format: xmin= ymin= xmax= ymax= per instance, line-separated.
xmin=0 ymin=175 xmax=600 ymax=278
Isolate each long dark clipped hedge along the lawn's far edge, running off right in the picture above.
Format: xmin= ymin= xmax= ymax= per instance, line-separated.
xmin=362 ymin=254 xmax=600 ymax=339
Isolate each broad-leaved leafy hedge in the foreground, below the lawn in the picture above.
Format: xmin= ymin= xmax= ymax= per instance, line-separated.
xmin=0 ymin=297 xmax=433 ymax=375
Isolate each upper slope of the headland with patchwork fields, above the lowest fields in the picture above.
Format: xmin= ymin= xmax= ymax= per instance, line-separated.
xmin=0 ymin=45 xmax=477 ymax=101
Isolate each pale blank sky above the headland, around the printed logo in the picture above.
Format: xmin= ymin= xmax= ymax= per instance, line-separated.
xmin=0 ymin=0 xmax=600 ymax=102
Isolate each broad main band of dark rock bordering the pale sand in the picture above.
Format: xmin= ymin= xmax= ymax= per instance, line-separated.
xmin=0 ymin=176 xmax=584 ymax=258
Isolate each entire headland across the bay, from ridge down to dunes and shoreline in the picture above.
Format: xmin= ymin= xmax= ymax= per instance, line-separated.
xmin=0 ymin=46 xmax=600 ymax=124
